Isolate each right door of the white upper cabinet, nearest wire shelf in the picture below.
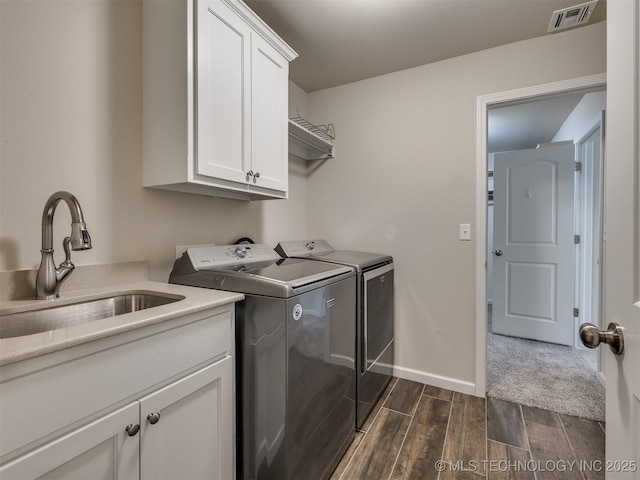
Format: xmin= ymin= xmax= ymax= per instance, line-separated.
xmin=251 ymin=33 xmax=289 ymax=191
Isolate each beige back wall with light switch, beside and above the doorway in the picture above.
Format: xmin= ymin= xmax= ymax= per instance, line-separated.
xmin=308 ymin=23 xmax=606 ymax=392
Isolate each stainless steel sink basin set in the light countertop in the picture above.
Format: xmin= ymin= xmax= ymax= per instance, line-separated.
xmin=0 ymin=292 xmax=184 ymax=339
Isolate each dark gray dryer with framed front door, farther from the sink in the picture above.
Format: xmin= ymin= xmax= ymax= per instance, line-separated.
xmin=276 ymin=240 xmax=394 ymax=428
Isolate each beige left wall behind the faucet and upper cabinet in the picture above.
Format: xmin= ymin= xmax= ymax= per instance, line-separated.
xmin=0 ymin=0 xmax=307 ymax=281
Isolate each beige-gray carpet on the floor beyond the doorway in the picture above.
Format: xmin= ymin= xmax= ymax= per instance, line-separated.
xmin=487 ymin=318 xmax=605 ymax=422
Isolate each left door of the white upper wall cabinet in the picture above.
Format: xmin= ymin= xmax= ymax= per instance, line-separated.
xmin=195 ymin=0 xmax=251 ymax=183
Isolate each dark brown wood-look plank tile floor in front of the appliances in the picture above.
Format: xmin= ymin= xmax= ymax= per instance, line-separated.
xmin=331 ymin=379 xmax=605 ymax=480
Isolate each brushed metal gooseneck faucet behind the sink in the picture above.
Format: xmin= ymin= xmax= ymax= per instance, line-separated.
xmin=36 ymin=192 xmax=91 ymax=300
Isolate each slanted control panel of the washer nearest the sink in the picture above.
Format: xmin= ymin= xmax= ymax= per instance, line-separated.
xmin=185 ymin=243 xmax=281 ymax=270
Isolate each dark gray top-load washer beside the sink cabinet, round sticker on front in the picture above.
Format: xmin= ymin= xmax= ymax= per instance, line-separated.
xmin=169 ymin=244 xmax=356 ymax=479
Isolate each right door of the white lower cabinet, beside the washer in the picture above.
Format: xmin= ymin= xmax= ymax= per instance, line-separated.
xmin=140 ymin=357 xmax=235 ymax=480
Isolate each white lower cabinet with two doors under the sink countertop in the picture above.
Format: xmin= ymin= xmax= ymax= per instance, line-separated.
xmin=0 ymin=307 xmax=235 ymax=480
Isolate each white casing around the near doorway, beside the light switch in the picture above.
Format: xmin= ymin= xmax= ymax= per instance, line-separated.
xmin=475 ymin=73 xmax=607 ymax=397
